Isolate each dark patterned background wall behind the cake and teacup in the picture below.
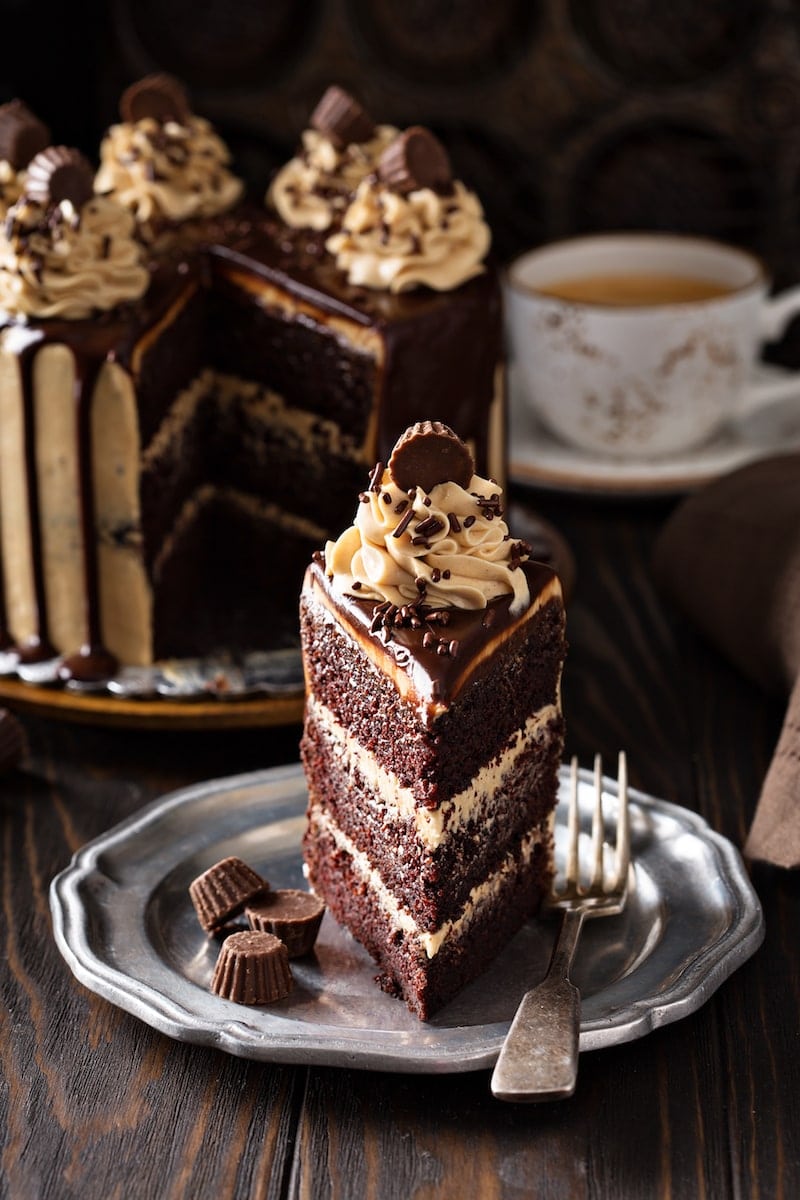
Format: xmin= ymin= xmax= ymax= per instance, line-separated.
xmin=6 ymin=0 xmax=800 ymax=358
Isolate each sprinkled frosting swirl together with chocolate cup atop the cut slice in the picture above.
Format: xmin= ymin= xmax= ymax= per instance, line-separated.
xmin=325 ymin=421 xmax=530 ymax=630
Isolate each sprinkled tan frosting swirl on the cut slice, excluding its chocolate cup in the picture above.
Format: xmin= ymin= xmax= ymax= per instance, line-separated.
xmin=325 ymin=470 xmax=530 ymax=617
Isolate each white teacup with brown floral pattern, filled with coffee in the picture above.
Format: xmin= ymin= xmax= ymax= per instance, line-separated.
xmin=506 ymin=233 xmax=800 ymax=458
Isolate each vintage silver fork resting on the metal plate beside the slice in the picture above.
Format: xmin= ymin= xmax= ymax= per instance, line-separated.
xmin=492 ymin=751 xmax=631 ymax=1100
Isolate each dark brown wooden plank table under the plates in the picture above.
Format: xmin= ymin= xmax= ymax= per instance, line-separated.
xmin=0 ymin=492 xmax=800 ymax=1200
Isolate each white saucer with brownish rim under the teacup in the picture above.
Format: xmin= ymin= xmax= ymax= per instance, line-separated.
xmin=509 ymin=366 xmax=800 ymax=496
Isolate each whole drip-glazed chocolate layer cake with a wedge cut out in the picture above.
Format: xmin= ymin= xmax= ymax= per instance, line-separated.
xmin=0 ymin=77 xmax=504 ymax=679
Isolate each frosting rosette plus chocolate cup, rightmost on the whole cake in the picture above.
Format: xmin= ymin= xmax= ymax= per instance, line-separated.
xmin=326 ymin=127 xmax=492 ymax=292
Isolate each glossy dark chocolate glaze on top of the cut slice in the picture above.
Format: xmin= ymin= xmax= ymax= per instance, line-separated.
xmin=307 ymin=552 xmax=560 ymax=708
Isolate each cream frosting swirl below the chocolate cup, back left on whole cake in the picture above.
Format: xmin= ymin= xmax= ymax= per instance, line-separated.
xmin=95 ymin=115 xmax=243 ymax=238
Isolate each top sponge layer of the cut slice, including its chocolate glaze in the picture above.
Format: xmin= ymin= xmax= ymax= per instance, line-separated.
xmin=301 ymin=564 xmax=564 ymax=808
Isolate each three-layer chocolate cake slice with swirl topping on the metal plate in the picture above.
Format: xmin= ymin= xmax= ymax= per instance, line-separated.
xmin=301 ymin=422 xmax=565 ymax=1020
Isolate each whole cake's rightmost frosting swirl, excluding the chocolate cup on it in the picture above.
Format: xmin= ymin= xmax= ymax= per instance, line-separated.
xmin=325 ymin=178 xmax=492 ymax=292
